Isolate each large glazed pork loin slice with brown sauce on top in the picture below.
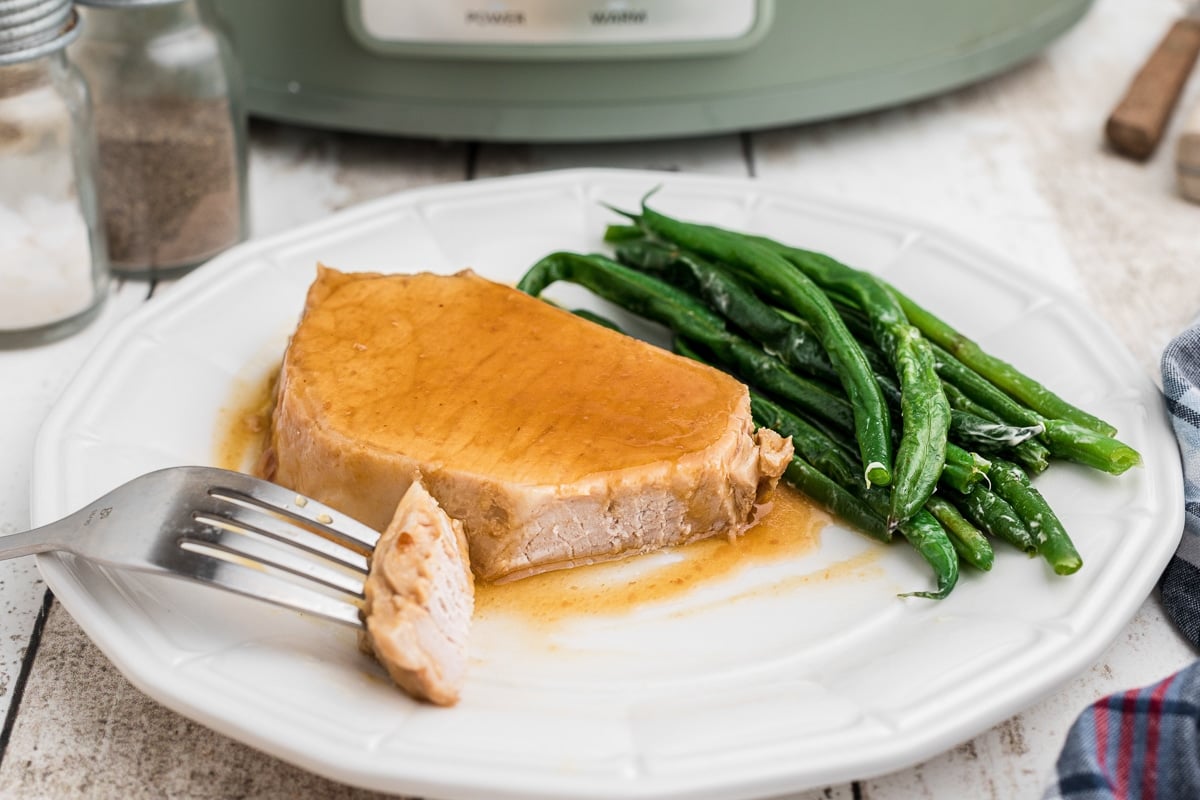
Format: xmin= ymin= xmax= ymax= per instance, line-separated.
xmin=272 ymin=267 xmax=791 ymax=581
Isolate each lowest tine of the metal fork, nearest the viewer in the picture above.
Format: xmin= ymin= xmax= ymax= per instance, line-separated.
xmin=162 ymin=548 xmax=362 ymax=628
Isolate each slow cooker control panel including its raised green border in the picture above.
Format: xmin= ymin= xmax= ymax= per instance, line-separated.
xmin=347 ymin=0 xmax=770 ymax=59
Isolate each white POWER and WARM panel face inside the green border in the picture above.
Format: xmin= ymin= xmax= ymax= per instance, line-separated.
xmin=356 ymin=0 xmax=761 ymax=50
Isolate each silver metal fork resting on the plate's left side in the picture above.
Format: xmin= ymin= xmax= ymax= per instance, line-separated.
xmin=0 ymin=467 xmax=379 ymax=627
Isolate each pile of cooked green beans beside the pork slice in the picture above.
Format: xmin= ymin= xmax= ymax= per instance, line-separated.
xmin=518 ymin=204 xmax=1140 ymax=599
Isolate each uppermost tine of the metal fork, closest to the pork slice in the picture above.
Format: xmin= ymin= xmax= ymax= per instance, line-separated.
xmin=200 ymin=469 xmax=379 ymax=554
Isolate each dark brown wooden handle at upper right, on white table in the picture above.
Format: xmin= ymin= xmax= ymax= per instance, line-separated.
xmin=1104 ymin=19 xmax=1200 ymax=160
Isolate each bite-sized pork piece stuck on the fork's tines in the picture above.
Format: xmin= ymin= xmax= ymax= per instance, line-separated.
xmin=359 ymin=481 xmax=475 ymax=705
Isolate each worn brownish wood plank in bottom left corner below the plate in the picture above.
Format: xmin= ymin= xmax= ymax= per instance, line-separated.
xmin=0 ymin=604 xmax=410 ymax=800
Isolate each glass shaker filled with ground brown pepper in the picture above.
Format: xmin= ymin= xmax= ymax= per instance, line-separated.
xmin=70 ymin=0 xmax=246 ymax=278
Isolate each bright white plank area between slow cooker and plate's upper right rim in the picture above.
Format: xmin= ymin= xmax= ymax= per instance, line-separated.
xmin=751 ymin=65 xmax=1080 ymax=299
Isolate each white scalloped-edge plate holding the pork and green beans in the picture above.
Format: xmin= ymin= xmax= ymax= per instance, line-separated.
xmin=34 ymin=170 xmax=1182 ymax=799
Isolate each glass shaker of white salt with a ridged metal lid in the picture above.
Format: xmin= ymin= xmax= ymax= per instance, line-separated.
xmin=0 ymin=0 xmax=108 ymax=347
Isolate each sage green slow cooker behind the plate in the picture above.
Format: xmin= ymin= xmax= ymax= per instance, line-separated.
xmin=212 ymin=0 xmax=1091 ymax=142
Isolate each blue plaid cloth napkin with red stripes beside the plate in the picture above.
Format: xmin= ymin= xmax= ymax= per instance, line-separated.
xmin=1044 ymin=325 xmax=1200 ymax=800
